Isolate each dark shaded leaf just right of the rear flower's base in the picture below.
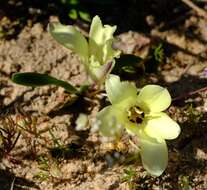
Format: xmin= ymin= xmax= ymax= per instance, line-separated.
xmin=113 ymin=54 xmax=142 ymax=73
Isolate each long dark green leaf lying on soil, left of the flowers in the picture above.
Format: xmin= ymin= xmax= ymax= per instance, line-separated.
xmin=11 ymin=72 xmax=78 ymax=93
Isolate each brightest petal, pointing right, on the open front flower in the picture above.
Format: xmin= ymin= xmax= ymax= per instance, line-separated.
xmin=144 ymin=113 xmax=180 ymax=139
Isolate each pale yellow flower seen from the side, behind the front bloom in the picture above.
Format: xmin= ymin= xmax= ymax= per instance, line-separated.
xmin=48 ymin=16 xmax=120 ymax=82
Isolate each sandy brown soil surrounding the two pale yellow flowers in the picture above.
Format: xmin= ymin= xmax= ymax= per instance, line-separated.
xmin=0 ymin=3 xmax=207 ymax=190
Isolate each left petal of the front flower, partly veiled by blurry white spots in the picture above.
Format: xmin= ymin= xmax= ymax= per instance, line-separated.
xmin=97 ymin=106 xmax=124 ymax=137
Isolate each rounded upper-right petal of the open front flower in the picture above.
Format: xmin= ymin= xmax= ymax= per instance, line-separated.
xmin=137 ymin=85 xmax=171 ymax=112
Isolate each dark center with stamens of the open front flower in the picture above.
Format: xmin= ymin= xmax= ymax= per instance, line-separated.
xmin=127 ymin=106 xmax=144 ymax=124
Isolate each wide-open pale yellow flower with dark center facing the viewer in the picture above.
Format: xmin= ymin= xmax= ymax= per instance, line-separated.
xmin=97 ymin=75 xmax=180 ymax=176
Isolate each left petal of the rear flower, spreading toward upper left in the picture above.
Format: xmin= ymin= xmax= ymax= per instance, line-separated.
xmin=48 ymin=22 xmax=88 ymax=61
